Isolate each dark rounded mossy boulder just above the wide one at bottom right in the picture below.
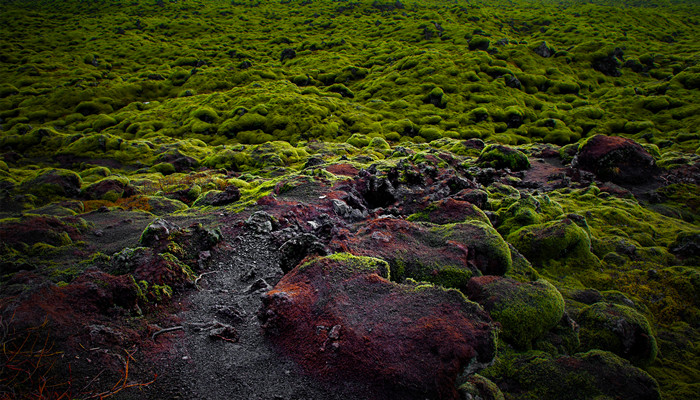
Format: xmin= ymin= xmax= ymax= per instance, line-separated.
xmin=576 ymin=302 xmax=658 ymax=367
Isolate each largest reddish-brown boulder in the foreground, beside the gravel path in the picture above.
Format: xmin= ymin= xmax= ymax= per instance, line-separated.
xmin=259 ymin=253 xmax=495 ymax=399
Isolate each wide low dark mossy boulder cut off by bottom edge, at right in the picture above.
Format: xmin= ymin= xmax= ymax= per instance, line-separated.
xmin=481 ymin=350 xmax=661 ymax=400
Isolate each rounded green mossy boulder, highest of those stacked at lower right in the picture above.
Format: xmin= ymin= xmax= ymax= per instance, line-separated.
xmin=507 ymin=217 xmax=600 ymax=269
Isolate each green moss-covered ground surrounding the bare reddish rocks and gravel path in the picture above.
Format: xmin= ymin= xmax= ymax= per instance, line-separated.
xmin=0 ymin=0 xmax=700 ymax=399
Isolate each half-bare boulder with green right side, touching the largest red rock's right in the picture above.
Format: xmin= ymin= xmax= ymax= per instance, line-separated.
xmin=466 ymin=276 xmax=564 ymax=348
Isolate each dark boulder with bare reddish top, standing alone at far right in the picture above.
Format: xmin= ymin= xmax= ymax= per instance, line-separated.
xmin=572 ymin=135 xmax=656 ymax=184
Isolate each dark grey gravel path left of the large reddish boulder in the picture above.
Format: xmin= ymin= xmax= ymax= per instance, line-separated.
xmin=135 ymin=220 xmax=366 ymax=400
